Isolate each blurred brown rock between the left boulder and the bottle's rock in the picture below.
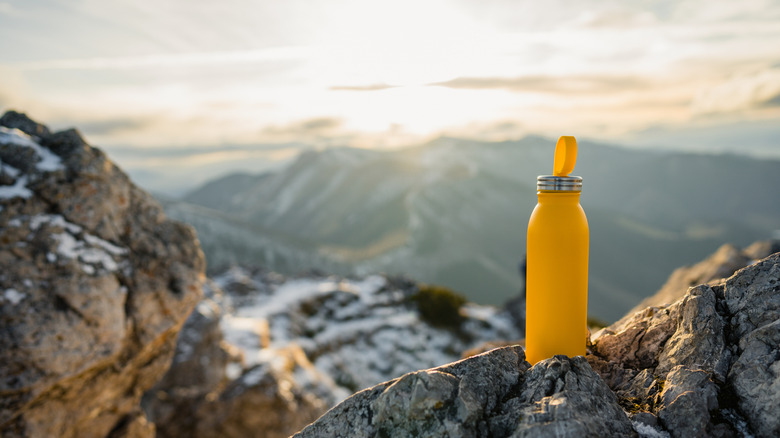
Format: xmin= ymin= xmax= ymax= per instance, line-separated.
xmin=144 ymin=279 xmax=349 ymax=438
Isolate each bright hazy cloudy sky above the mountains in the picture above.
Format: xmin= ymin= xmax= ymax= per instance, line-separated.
xmin=0 ymin=0 xmax=780 ymax=192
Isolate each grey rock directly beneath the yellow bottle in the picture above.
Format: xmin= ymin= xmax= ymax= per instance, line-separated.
xmin=295 ymin=346 xmax=636 ymax=438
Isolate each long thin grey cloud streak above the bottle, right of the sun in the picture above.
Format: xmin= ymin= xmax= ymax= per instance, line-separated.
xmin=429 ymin=75 xmax=650 ymax=94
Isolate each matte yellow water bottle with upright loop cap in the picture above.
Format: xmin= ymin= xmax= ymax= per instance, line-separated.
xmin=525 ymin=136 xmax=589 ymax=364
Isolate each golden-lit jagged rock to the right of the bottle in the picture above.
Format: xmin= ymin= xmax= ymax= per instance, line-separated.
xmin=588 ymin=253 xmax=780 ymax=437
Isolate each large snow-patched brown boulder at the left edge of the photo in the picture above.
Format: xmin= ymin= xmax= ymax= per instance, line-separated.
xmin=0 ymin=112 xmax=205 ymax=437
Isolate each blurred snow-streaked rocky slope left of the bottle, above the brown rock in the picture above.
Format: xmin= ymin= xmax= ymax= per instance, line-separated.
xmin=214 ymin=267 xmax=519 ymax=391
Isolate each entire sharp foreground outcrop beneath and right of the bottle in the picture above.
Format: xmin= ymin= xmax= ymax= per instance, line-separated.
xmin=296 ymin=253 xmax=780 ymax=438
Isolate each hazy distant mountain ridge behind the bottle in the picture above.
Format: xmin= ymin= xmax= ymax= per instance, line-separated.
xmin=167 ymin=137 xmax=780 ymax=319
